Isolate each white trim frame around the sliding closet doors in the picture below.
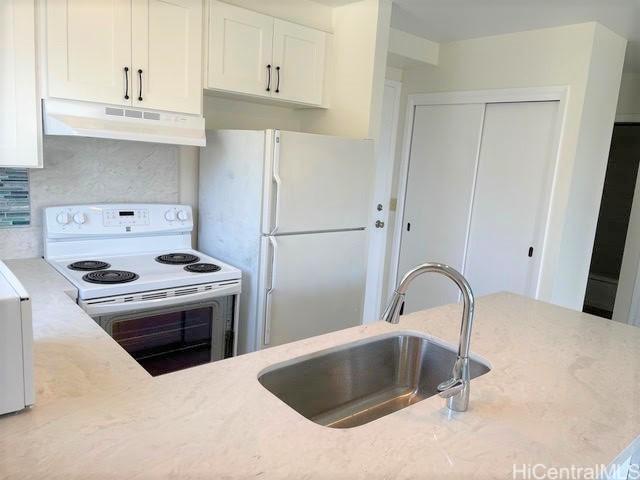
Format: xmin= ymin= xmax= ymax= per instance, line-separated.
xmin=389 ymin=86 xmax=569 ymax=298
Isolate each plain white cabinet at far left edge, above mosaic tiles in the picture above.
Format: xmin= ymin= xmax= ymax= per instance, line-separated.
xmin=0 ymin=0 xmax=42 ymax=167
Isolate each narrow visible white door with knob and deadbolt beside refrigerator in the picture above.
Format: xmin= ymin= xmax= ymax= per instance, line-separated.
xmin=364 ymin=80 xmax=402 ymax=323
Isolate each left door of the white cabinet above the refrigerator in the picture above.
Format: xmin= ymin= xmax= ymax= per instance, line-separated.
xmin=207 ymin=1 xmax=274 ymax=97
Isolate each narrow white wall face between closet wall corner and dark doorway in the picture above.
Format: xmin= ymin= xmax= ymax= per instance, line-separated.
xmin=545 ymin=24 xmax=626 ymax=310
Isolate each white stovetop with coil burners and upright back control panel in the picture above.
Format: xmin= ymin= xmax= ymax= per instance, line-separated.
xmin=44 ymin=203 xmax=242 ymax=300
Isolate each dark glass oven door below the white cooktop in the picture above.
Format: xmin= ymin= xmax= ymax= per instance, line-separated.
xmin=94 ymin=295 xmax=234 ymax=376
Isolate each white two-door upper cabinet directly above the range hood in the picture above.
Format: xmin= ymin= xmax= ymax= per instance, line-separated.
xmin=46 ymin=0 xmax=202 ymax=114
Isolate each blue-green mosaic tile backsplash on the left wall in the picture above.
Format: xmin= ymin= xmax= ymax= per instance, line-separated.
xmin=0 ymin=168 xmax=31 ymax=228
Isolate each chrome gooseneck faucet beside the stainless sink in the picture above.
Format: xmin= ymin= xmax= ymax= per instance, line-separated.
xmin=382 ymin=263 xmax=474 ymax=412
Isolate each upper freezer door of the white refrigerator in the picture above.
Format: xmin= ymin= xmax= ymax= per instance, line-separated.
xmin=263 ymin=130 xmax=375 ymax=234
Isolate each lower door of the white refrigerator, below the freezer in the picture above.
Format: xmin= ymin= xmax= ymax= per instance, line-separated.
xmin=260 ymin=230 xmax=366 ymax=346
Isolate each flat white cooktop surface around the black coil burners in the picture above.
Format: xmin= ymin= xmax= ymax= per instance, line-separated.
xmin=48 ymin=249 xmax=241 ymax=300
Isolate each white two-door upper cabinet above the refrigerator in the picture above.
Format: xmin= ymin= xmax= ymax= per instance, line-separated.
xmin=206 ymin=0 xmax=327 ymax=106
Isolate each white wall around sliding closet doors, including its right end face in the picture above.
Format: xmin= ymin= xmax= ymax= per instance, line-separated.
xmin=394 ymin=23 xmax=626 ymax=309
